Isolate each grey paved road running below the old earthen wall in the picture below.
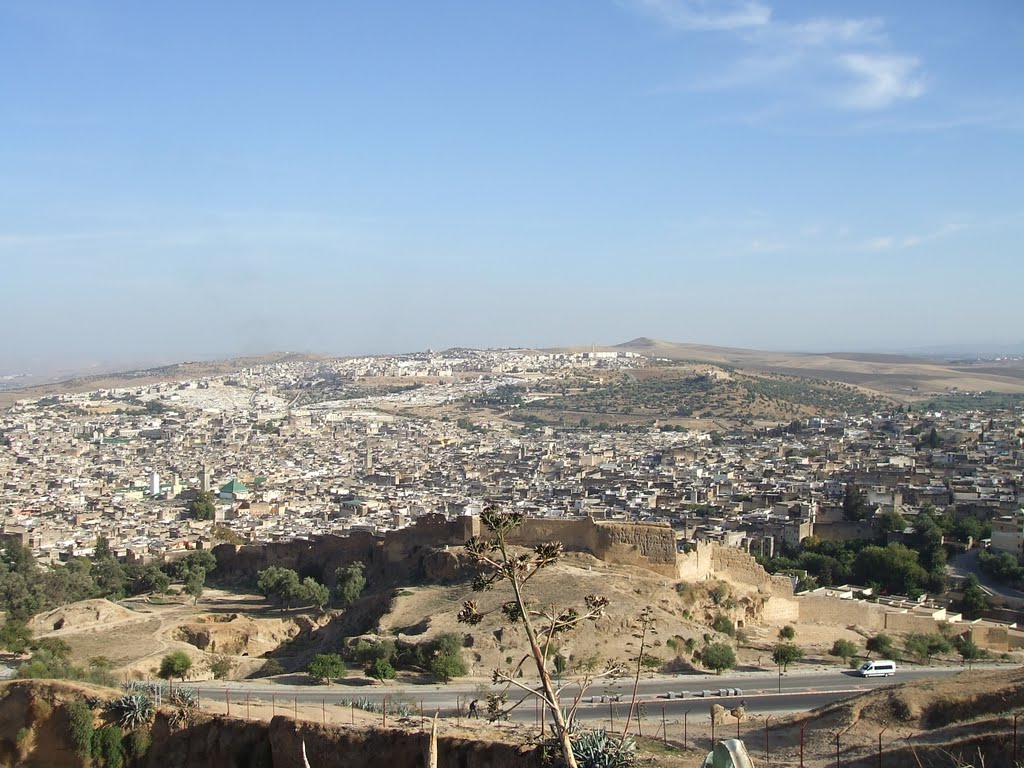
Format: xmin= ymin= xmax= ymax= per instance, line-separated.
xmin=197 ymin=665 xmax=991 ymax=721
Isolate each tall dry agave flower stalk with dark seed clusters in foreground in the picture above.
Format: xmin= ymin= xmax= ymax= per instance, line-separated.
xmin=458 ymin=507 xmax=608 ymax=768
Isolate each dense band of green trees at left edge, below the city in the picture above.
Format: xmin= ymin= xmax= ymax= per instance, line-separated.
xmin=0 ymin=538 xmax=217 ymax=621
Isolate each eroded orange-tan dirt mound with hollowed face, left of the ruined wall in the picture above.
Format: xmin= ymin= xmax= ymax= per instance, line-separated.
xmin=174 ymin=614 xmax=313 ymax=656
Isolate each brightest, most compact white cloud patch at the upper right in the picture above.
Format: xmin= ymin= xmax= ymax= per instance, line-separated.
xmin=836 ymin=53 xmax=925 ymax=110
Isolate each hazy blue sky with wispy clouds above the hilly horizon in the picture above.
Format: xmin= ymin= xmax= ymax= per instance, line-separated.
xmin=0 ymin=0 xmax=1024 ymax=370
